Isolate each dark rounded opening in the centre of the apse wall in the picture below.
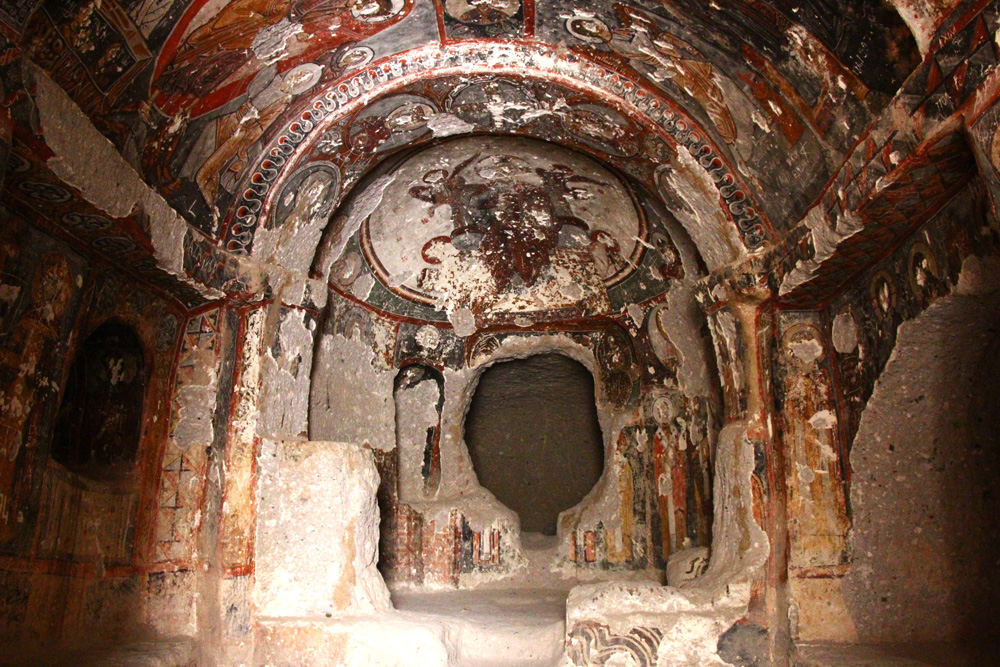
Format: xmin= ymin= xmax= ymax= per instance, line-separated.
xmin=465 ymin=354 xmax=604 ymax=535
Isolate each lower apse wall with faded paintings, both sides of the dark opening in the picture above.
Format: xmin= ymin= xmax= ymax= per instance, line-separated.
xmin=311 ymin=295 xmax=718 ymax=583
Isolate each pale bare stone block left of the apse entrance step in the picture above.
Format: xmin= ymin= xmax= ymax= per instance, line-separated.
xmin=254 ymin=440 xmax=394 ymax=665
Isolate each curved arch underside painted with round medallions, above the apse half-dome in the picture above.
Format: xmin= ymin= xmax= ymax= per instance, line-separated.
xmin=244 ymin=64 xmax=772 ymax=265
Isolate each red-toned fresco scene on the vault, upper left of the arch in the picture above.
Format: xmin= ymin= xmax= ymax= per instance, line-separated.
xmin=146 ymin=0 xmax=412 ymax=207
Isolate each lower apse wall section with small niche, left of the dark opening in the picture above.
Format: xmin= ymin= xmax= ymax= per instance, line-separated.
xmin=310 ymin=294 xmax=532 ymax=586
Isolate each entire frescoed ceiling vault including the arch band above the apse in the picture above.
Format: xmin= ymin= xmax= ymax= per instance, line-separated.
xmin=0 ymin=0 xmax=919 ymax=287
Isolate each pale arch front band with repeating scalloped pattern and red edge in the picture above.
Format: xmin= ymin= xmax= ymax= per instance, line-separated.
xmin=222 ymin=43 xmax=773 ymax=268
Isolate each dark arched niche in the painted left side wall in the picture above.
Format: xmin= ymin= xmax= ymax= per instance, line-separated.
xmin=52 ymin=320 xmax=146 ymax=479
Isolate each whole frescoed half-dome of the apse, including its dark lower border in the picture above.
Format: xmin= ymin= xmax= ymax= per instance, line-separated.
xmin=321 ymin=137 xmax=692 ymax=321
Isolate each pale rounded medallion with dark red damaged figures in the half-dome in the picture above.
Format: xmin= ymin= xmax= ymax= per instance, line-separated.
xmin=361 ymin=137 xmax=647 ymax=304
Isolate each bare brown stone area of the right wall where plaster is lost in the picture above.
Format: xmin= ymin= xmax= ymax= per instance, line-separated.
xmin=844 ymin=276 xmax=1000 ymax=642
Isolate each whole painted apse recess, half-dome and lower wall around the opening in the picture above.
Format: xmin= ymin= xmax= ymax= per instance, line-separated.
xmin=309 ymin=136 xmax=728 ymax=586
